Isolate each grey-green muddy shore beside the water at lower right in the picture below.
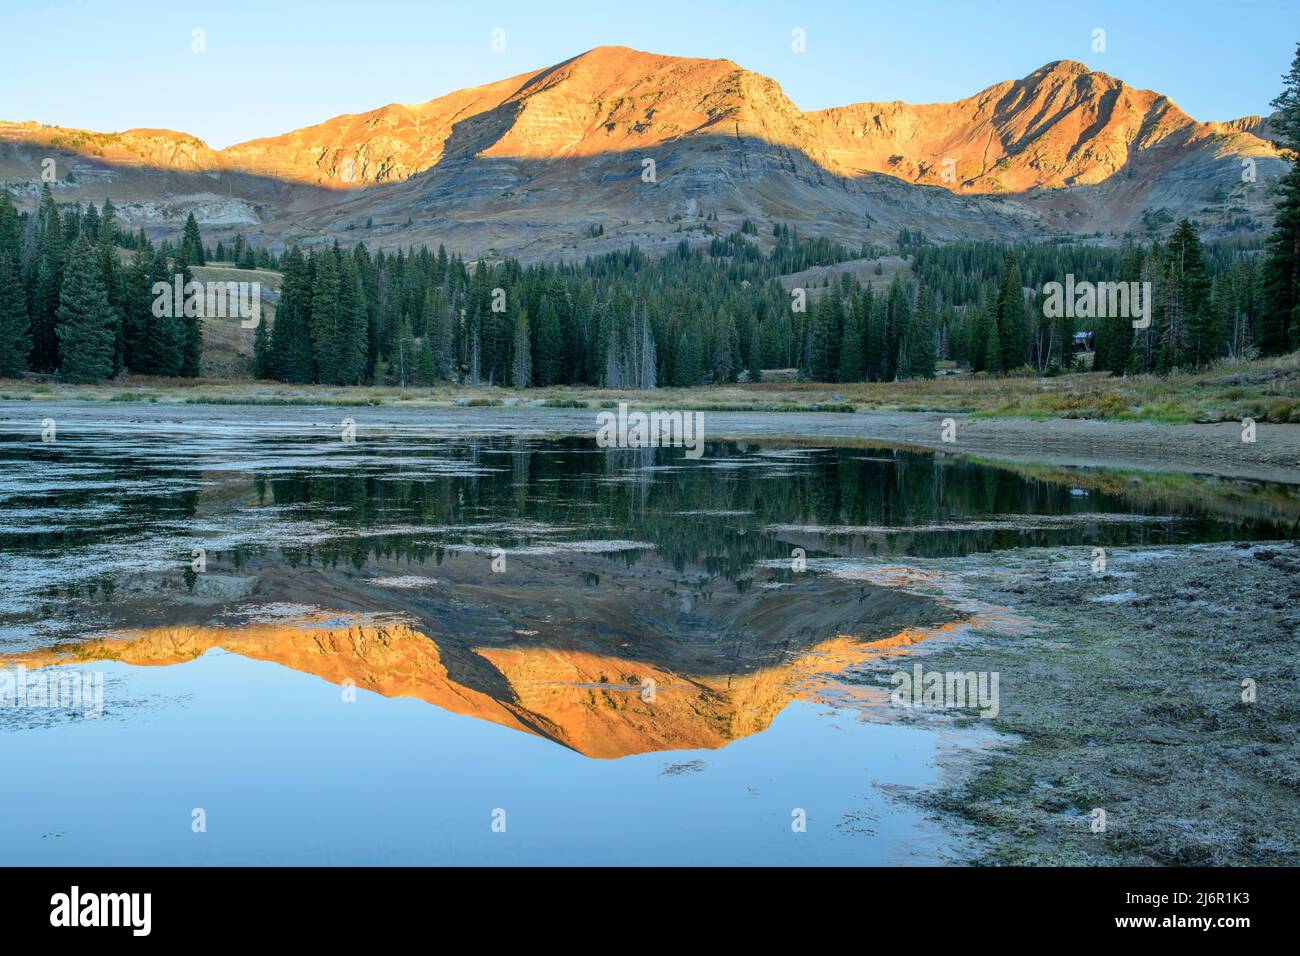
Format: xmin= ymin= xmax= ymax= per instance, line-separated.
xmin=862 ymin=544 xmax=1300 ymax=866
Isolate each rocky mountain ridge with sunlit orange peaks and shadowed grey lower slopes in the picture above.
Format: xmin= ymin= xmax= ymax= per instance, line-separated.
xmin=0 ymin=47 xmax=1284 ymax=259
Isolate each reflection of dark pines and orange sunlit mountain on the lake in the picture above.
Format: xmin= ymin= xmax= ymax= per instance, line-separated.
xmin=0 ymin=432 xmax=1287 ymax=757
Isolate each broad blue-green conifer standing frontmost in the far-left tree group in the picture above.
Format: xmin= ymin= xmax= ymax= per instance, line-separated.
xmin=55 ymin=235 xmax=113 ymax=382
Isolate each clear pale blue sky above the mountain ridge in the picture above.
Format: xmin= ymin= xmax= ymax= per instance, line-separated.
xmin=0 ymin=0 xmax=1300 ymax=147
